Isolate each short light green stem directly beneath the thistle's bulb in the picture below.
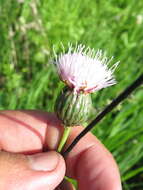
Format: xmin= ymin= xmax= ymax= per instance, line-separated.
xmin=58 ymin=127 xmax=71 ymax=152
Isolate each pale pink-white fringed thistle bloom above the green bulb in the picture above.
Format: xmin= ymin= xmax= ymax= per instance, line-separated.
xmin=56 ymin=44 xmax=118 ymax=93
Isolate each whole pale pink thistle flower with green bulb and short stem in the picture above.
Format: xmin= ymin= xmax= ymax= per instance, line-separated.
xmin=55 ymin=44 xmax=118 ymax=152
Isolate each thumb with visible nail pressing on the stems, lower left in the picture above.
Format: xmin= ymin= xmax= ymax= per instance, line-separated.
xmin=0 ymin=151 xmax=65 ymax=190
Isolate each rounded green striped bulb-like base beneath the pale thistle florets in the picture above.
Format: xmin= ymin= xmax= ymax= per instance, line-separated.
xmin=55 ymin=87 xmax=92 ymax=127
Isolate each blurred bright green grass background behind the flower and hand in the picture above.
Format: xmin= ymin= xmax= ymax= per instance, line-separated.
xmin=0 ymin=0 xmax=143 ymax=190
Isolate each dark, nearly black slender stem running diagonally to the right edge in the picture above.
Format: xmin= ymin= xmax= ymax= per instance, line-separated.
xmin=62 ymin=74 xmax=143 ymax=156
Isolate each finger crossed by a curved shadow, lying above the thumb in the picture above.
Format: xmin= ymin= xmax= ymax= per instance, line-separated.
xmin=0 ymin=110 xmax=63 ymax=154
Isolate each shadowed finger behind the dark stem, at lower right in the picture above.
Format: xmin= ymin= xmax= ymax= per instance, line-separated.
xmin=63 ymin=126 xmax=122 ymax=190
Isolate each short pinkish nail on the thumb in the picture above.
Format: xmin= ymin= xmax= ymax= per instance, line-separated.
xmin=28 ymin=151 xmax=60 ymax=171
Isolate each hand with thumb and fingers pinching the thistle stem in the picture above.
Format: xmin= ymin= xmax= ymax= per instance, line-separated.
xmin=0 ymin=111 xmax=121 ymax=190
